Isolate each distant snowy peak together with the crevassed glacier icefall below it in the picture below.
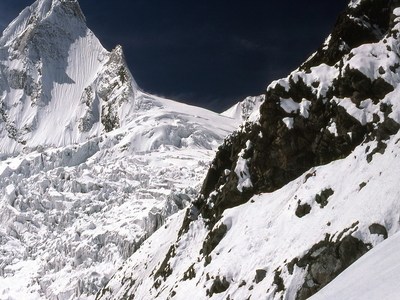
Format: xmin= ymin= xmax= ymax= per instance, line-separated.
xmin=0 ymin=0 xmax=247 ymax=299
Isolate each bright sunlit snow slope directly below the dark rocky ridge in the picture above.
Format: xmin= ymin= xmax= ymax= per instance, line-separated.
xmin=98 ymin=120 xmax=400 ymax=299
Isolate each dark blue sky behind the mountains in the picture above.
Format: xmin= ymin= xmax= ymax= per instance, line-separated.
xmin=0 ymin=0 xmax=348 ymax=111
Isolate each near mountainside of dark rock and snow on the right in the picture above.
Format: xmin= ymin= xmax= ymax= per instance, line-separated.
xmin=96 ymin=0 xmax=400 ymax=300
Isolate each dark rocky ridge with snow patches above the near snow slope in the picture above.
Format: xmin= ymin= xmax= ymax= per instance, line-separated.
xmin=196 ymin=1 xmax=399 ymax=226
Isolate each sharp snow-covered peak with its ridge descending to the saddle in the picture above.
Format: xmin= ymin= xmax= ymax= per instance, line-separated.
xmin=0 ymin=0 xmax=244 ymax=155
